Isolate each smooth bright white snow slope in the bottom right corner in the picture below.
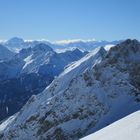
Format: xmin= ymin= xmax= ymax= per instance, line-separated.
xmin=81 ymin=111 xmax=140 ymax=140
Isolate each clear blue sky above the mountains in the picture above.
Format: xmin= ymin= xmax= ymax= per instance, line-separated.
xmin=0 ymin=0 xmax=140 ymax=41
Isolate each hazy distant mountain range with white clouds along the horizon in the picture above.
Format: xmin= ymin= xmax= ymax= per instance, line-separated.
xmin=1 ymin=37 xmax=121 ymax=51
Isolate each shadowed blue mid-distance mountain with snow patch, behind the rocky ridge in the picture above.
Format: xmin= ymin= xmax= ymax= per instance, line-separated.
xmin=0 ymin=43 xmax=86 ymax=120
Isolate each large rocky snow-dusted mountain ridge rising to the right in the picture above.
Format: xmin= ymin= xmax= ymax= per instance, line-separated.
xmin=1 ymin=40 xmax=140 ymax=140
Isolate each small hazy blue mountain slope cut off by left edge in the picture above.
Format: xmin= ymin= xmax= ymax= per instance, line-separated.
xmin=0 ymin=45 xmax=15 ymax=61
